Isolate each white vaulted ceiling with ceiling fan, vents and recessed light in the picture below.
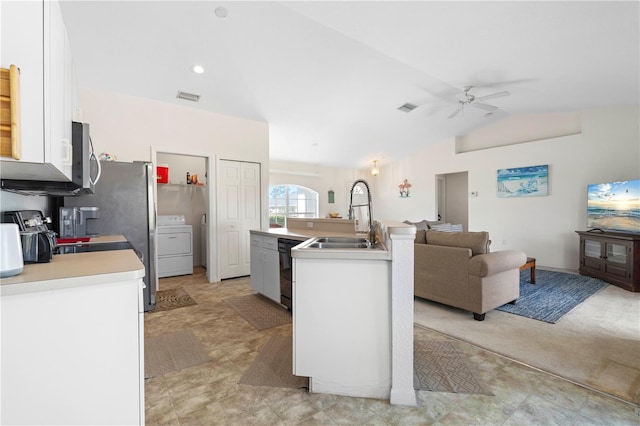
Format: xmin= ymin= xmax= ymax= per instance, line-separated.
xmin=57 ymin=0 xmax=640 ymax=171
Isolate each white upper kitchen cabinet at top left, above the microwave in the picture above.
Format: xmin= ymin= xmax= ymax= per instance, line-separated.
xmin=0 ymin=0 xmax=75 ymax=181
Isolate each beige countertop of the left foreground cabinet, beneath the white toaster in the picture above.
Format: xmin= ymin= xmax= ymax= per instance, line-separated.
xmin=0 ymin=250 xmax=145 ymax=296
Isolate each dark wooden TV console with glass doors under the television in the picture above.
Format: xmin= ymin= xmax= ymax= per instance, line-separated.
xmin=576 ymin=231 xmax=640 ymax=292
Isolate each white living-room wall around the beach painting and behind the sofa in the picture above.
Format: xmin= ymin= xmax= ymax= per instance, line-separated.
xmin=373 ymin=107 xmax=640 ymax=270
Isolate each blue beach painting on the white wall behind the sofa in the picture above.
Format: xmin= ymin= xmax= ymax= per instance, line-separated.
xmin=498 ymin=164 xmax=549 ymax=198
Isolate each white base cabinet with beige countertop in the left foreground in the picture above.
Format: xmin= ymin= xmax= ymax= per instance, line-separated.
xmin=0 ymin=250 xmax=145 ymax=424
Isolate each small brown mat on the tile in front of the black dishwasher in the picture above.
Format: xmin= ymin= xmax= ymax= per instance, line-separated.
xmin=224 ymin=294 xmax=291 ymax=330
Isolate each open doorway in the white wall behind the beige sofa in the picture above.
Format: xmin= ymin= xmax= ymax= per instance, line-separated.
xmin=436 ymin=172 xmax=469 ymax=231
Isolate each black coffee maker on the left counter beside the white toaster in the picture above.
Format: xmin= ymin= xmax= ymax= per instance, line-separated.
xmin=2 ymin=210 xmax=57 ymax=263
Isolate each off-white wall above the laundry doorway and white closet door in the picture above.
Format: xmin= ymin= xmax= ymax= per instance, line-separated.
xmin=80 ymin=89 xmax=269 ymax=230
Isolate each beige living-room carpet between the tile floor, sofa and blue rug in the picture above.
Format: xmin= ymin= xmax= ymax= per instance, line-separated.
xmin=415 ymin=285 xmax=640 ymax=404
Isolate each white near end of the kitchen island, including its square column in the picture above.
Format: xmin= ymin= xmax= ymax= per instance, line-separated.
xmin=291 ymin=222 xmax=416 ymax=405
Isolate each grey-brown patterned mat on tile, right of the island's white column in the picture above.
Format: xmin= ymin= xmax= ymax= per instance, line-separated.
xmin=413 ymin=340 xmax=493 ymax=396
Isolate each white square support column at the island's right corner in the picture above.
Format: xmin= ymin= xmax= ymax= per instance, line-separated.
xmin=389 ymin=227 xmax=418 ymax=406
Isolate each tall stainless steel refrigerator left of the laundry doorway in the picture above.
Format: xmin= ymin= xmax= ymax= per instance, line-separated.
xmin=64 ymin=161 xmax=157 ymax=311
